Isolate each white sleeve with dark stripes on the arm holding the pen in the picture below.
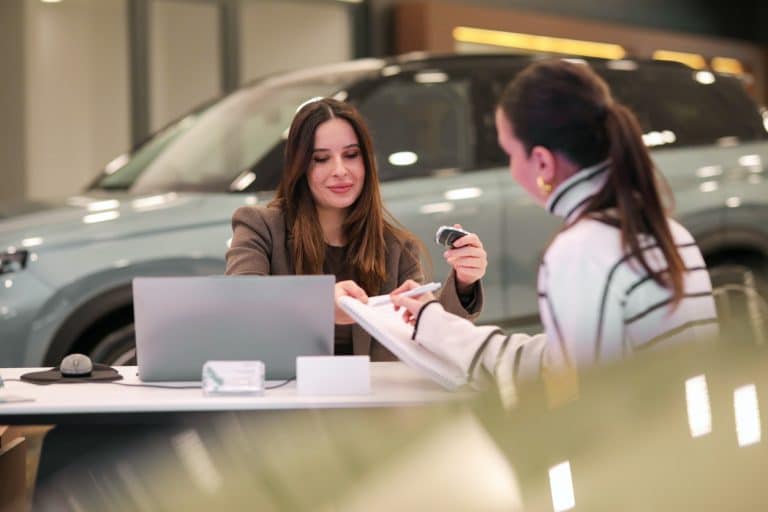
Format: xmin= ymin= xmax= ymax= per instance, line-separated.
xmin=415 ymin=302 xmax=546 ymax=383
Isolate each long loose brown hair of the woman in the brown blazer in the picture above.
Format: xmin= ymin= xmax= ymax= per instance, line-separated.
xmin=270 ymin=98 xmax=422 ymax=294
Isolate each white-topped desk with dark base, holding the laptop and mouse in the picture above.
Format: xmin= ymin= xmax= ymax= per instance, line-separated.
xmin=0 ymin=363 xmax=467 ymax=490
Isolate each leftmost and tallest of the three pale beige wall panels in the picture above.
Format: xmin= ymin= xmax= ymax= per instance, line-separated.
xmin=24 ymin=0 xmax=130 ymax=198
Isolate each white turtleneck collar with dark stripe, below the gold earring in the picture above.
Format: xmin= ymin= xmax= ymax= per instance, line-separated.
xmin=546 ymin=160 xmax=610 ymax=222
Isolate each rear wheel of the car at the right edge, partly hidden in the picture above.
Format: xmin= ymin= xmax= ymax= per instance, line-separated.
xmin=709 ymin=263 xmax=768 ymax=345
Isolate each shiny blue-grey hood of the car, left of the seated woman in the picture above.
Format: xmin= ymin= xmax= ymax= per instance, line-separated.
xmin=0 ymin=192 xmax=244 ymax=251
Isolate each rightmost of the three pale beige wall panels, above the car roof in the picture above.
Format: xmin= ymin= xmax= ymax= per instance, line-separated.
xmin=240 ymin=0 xmax=353 ymax=83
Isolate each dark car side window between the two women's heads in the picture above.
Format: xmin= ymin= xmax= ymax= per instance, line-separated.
xmin=359 ymin=72 xmax=474 ymax=181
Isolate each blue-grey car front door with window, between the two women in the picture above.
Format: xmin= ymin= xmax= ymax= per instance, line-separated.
xmin=357 ymin=67 xmax=507 ymax=322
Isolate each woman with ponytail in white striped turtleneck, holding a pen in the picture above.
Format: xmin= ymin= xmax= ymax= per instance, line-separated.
xmin=392 ymin=60 xmax=717 ymax=388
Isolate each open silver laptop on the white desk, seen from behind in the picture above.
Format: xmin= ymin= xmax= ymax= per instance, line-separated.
xmin=133 ymin=275 xmax=335 ymax=381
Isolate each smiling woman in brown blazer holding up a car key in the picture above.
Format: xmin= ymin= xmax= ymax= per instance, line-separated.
xmin=226 ymin=98 xmax=487 ymax=360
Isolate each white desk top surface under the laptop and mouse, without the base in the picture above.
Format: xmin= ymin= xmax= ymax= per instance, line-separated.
xmin=0 ymin=363 xmax=463 ymax=423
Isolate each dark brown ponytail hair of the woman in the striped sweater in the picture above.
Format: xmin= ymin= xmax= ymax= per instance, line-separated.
xmin=499 ymin=60 xmax=685 ymax=304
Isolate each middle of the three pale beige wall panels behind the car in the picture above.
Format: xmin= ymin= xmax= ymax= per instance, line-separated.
xmin=149 ymin=0 xmax=221 ymax=131
